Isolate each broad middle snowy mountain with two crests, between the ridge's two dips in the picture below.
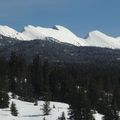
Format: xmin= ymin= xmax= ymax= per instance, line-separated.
xmin=22 ymin=25 xmax=85 ymax=46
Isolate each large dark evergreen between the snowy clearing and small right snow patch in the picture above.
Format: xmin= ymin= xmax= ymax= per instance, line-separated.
xmin=69 ymin=88 xmax=94 ymax=120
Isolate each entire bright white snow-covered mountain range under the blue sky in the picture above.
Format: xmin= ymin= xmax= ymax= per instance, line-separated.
xmin=0 ymin=25 xmax=120 ymax=49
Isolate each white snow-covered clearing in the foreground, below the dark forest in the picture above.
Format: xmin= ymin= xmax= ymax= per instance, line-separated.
xmin=0 ymin=99 xmax=103 ymax=120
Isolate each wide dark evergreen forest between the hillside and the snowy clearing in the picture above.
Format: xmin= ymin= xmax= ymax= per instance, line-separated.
xmin=0 ymin=52 xmax=120 ymax=120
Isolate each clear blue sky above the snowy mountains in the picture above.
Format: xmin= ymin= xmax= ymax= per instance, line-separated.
xmin=0 ymin=0 xmax=120 ymax=37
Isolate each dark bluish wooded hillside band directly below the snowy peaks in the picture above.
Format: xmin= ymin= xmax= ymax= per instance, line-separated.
xmin=0 ymin=38 xmax=120 ymax=63
